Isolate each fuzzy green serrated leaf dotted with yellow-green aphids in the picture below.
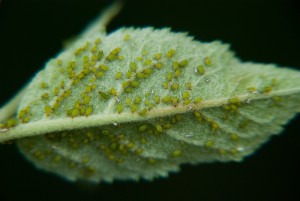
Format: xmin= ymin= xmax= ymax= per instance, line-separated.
xmin=0 ymin=3 xmax=300 ymax=183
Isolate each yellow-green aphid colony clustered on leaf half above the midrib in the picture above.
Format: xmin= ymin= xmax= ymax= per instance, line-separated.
xmin=0 ymin=30 xmax=277 ymax=128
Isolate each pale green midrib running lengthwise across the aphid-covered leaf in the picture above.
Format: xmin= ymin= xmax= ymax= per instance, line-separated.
xmin=0 ymin=88 xmax=300 ymax=142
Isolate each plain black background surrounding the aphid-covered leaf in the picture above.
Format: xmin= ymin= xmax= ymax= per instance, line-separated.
xmin=0 ymin=0 xmax=300 ymax=201
